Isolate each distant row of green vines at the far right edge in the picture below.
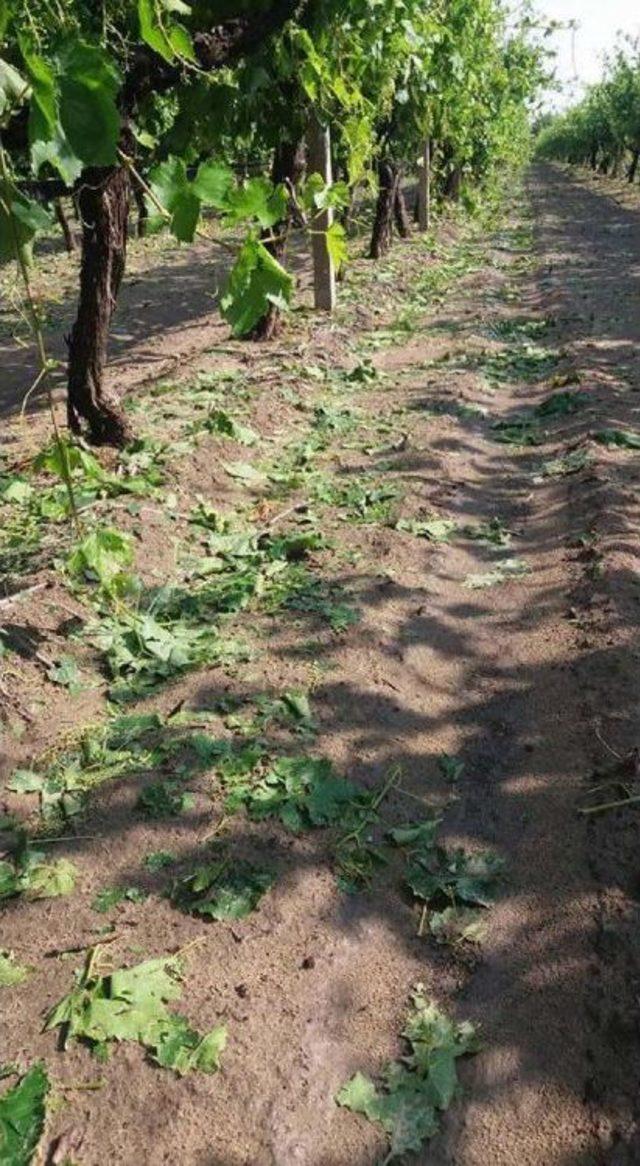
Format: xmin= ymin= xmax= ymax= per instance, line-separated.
xmin=537 ymin=37 xmax=640 ymax=182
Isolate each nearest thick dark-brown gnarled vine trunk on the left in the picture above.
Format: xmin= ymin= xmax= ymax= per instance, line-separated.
xmin=68 ymin=166 xmax=133 ymax=447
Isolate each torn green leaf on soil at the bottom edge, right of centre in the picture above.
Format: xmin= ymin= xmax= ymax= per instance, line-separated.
xmin=336 ymin=984 xmax=479 ymax=1163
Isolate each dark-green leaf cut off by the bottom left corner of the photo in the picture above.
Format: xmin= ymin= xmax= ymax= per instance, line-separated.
xmin=0 ymin=1063 xmax=49 ymax=1166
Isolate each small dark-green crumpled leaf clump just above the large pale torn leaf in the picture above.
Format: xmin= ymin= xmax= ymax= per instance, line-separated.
xmin=171 ymin=857 xmax=273 ymax=920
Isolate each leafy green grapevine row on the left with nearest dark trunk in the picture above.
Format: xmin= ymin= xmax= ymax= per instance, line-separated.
xmin=0 ymin=0 xmax=544 ymax=447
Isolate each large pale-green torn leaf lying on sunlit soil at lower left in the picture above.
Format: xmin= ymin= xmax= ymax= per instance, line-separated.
xmin=44 ymin=948 xmax=226 ymax=1076
